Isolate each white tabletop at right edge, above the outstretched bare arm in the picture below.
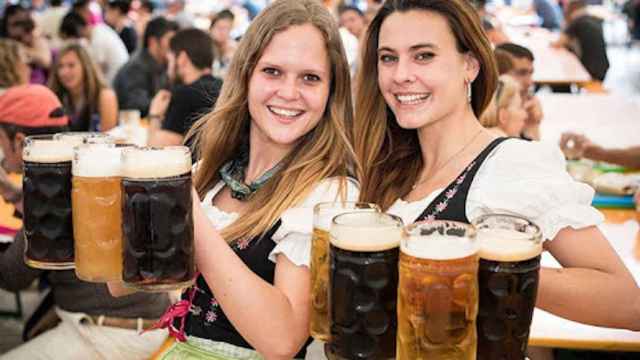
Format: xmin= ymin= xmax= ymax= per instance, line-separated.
xmin=539 ymin=94 xmax=640 ymax=148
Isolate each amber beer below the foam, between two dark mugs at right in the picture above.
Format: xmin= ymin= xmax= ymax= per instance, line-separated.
xmin=396 ymin=252 xmax=478 ymax=360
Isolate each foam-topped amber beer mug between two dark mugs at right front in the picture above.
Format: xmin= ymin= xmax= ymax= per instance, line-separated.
xmin=397 ymin=221 xmax=478 ymax=360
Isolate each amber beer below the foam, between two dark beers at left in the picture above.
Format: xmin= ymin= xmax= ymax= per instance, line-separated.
xmin=71 ymin=176 xmax=122 ymax=282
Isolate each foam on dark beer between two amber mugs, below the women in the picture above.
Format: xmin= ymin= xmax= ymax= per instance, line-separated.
xmin=330 ymin=212 xmax=402 ymax=252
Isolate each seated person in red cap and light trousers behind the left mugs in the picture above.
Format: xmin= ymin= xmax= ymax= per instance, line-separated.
xmin=0 ymin=85 xmax=169 ymax=360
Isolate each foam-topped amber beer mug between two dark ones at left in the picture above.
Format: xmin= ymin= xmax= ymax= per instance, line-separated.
xmin=71 ymin=143 xmax=131 ymax=282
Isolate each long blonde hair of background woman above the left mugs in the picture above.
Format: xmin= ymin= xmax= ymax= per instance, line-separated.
xmin=49 ymin=44 xmax=107 ymax=124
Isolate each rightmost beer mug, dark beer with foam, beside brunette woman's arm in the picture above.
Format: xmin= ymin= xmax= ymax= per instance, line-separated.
xmin=474 ymin=214 xmax=542 ymax=360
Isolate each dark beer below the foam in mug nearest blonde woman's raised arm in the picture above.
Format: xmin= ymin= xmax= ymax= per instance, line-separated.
xmin=122 ymin=174 xmax=195 ymax=287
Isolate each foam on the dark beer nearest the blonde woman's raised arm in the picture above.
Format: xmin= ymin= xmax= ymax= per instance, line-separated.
xmin=122 ymin=146 xmax=191 ymax=179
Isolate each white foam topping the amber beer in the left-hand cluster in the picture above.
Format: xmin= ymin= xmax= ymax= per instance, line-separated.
xmin=71 ymin=145 xmax=122 ymax=177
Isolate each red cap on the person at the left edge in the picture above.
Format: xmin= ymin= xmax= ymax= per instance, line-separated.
xmin=0 ymin=85 xmax=69 ymax=127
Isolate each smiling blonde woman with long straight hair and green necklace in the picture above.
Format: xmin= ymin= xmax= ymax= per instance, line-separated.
xmin=149 ymin=0 xmax=357 ymax=359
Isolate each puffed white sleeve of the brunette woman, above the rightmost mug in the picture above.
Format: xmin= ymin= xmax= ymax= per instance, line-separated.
xmin=466 ymin=139 xmax=604 ymax=240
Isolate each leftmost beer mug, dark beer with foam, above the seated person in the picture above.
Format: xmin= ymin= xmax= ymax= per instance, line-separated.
xmin=22 ymin=135 xmax=74 ymax=270
